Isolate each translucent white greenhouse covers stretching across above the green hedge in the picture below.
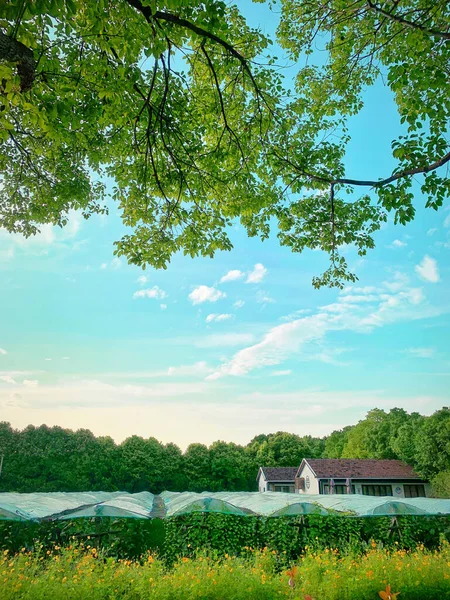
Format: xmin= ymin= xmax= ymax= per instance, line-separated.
xmin=0 ymin=492 xmax=450 ymax=521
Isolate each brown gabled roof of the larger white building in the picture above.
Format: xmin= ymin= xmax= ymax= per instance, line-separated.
xmin=297 ymin=458 xmax=421 ymax=480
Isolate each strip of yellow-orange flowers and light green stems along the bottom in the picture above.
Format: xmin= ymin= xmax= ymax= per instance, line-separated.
xmin=0 ymin=540 xmax=450 ymax=600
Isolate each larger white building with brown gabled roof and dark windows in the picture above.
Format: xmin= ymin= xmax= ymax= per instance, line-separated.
xmin=295 ymin=458 xmax=429 ymax=498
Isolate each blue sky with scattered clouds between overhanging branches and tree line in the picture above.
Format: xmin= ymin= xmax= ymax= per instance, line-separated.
xmin=0 ymin=2 xmax=450 ymax=447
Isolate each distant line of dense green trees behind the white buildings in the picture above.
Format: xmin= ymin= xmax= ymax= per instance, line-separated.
xmin=0 ymin=407 xmax=450 ymax=496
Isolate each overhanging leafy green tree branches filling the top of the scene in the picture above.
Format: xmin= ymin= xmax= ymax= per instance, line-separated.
xmin=0 ymin=0 xmax=450 ymax=286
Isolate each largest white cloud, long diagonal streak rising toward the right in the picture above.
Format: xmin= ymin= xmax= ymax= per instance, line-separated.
xmin=207 ymin=277 xmax=440 ymax=380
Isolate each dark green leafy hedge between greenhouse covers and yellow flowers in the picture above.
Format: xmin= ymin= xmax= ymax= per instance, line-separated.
xmin=0 ymin=513 xmax=450 ymax=565
